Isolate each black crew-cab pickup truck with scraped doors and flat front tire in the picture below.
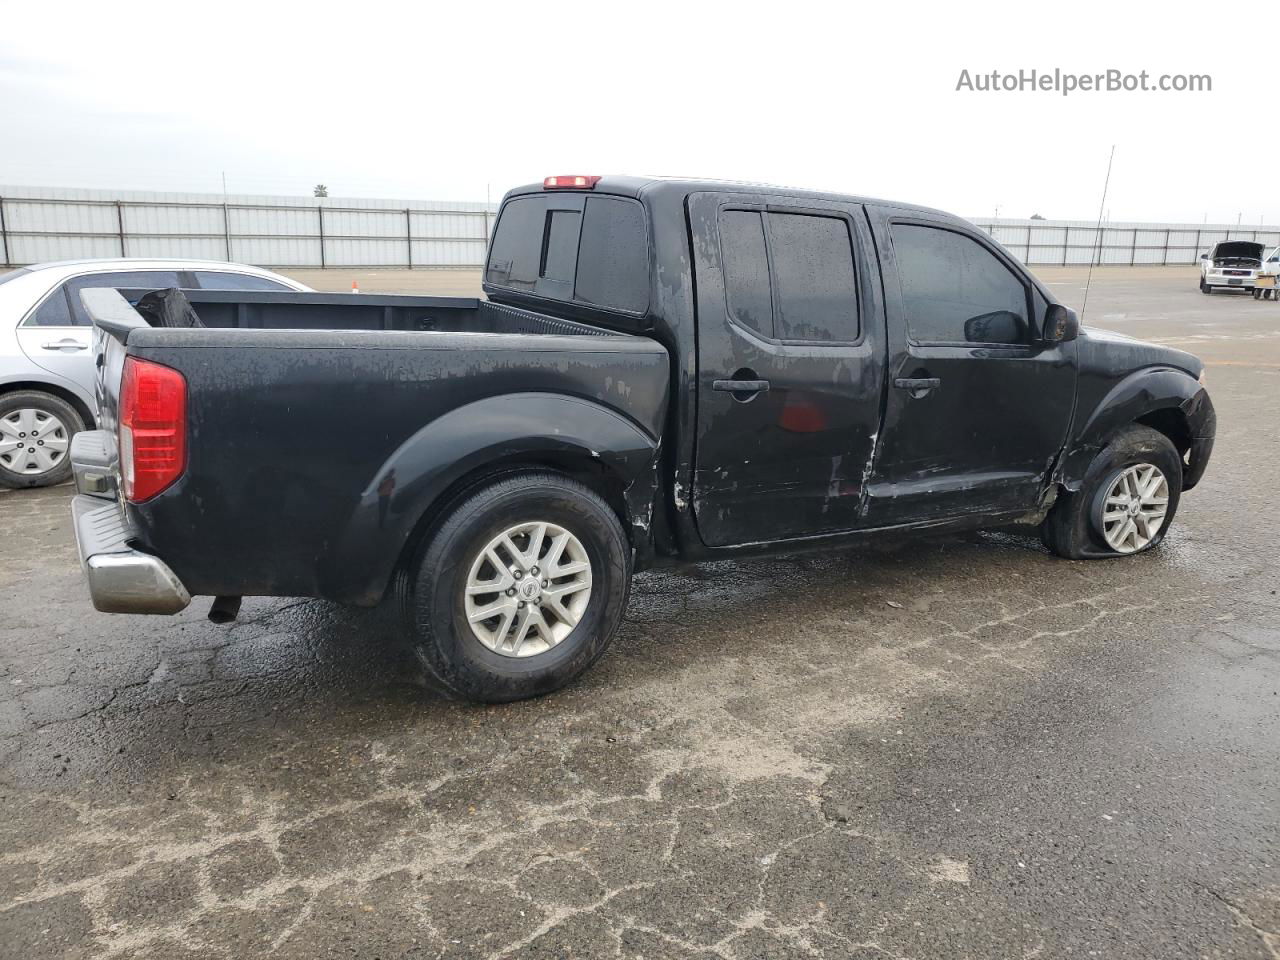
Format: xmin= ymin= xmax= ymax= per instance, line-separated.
xmin=72 ymin=177 xmax=1215 ymax=701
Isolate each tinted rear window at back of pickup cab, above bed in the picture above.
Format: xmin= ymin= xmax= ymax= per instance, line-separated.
xmin=485 ymin=193 xmax=649 ymax=314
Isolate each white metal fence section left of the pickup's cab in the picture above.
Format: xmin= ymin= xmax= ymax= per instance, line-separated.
xmin=0 ymin=187 xmax=495 ymax=268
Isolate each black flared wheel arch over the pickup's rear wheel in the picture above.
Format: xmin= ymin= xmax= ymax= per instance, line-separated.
xmin=320 ymin=393 xmax=658 ymax=605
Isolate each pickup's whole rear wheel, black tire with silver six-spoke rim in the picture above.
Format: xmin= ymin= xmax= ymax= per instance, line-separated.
xmin=399 ymin=471 xmax=631 ymax=703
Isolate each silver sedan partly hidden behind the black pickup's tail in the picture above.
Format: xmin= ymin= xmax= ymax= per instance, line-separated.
xmin=0 ymin=260 xmax=310 ymax=488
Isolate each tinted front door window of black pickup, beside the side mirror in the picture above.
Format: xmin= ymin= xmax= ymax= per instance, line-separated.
xmin=892 ymin=224 xmax=1030 ymax=343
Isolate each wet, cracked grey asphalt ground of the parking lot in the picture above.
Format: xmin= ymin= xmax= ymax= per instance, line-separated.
xmin=0 ymin=269 xmax=1280 ymax=960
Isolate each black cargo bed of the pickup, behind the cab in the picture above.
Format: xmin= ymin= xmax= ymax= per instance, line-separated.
xmin=84 ymin=291 xmax=669 ymax=604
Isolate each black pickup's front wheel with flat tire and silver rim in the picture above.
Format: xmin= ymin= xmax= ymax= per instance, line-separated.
xmin=1041 ymin=424 xmax=1183 ymax=559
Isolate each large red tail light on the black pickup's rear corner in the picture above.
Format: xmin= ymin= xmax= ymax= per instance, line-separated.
xmin=120 ymin=357 xmax=187 ymax=503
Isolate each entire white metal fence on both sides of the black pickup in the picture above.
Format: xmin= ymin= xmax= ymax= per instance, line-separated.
xmin=0 ymin=187 xmax=1280 ymax=268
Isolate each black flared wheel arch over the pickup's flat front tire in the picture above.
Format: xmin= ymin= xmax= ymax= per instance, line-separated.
xmin=1060 ymin=366 xmax=1217 ymax=490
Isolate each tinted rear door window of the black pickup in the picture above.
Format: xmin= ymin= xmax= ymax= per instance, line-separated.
xmin=719 ymin=210 xmax=859 ymax=343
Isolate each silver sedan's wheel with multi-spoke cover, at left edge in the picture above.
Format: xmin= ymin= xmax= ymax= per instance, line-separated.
xmin=0 ymin=390 xmax=84 ymax=489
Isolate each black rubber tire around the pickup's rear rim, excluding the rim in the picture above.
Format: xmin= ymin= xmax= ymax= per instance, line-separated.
xmin=399 ymin=471 xmax=631 ymax=703
